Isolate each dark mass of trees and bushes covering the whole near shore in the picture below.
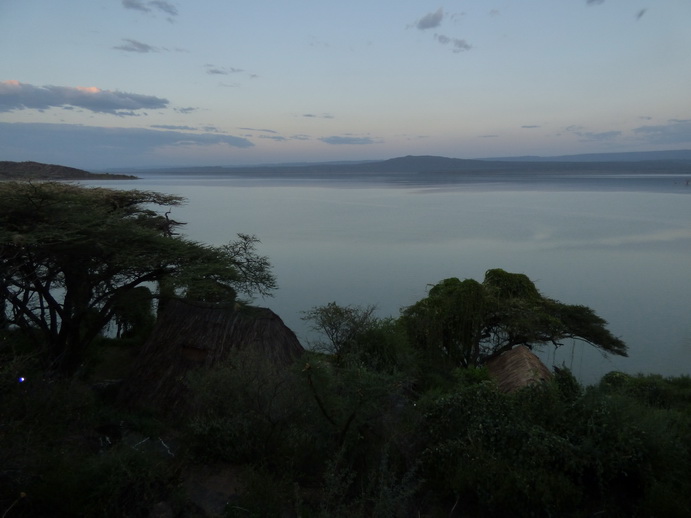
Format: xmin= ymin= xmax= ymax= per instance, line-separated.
xmin=0 ymin=184 xmax=691 ymax=518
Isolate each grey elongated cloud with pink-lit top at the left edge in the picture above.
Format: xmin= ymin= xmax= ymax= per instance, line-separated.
xmin=0 ymin=81 xmax=168 ymax=116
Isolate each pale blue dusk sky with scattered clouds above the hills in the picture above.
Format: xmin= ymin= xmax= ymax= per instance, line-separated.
xmin=0 ymin=0 xmax=691 ymax=170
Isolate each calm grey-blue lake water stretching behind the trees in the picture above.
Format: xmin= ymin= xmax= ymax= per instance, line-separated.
xmin=85 ymin=176 xmax=691 ymax=383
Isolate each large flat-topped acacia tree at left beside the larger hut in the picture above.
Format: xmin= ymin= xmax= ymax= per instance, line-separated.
xmin=0 ymin=182 xmax=276 ymax=373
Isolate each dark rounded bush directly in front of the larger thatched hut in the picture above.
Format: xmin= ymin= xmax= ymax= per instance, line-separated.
xmin=186 ymin=351 xmax=316 ymax=472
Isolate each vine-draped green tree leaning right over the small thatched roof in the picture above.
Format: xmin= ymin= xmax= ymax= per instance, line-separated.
xmin=401 ymin=269 xmax=627 ymax=367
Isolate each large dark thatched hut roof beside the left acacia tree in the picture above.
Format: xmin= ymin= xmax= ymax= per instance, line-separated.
xmin=120 ymin=301 xmax=304 ymax=413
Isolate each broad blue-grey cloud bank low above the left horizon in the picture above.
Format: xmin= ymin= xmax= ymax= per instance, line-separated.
xmin=0 ymin=122 xmax=254 ymax=169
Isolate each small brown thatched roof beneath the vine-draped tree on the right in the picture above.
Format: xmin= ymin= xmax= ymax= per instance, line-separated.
xmin=487 ymin=345 xmax=552 ymax=392
